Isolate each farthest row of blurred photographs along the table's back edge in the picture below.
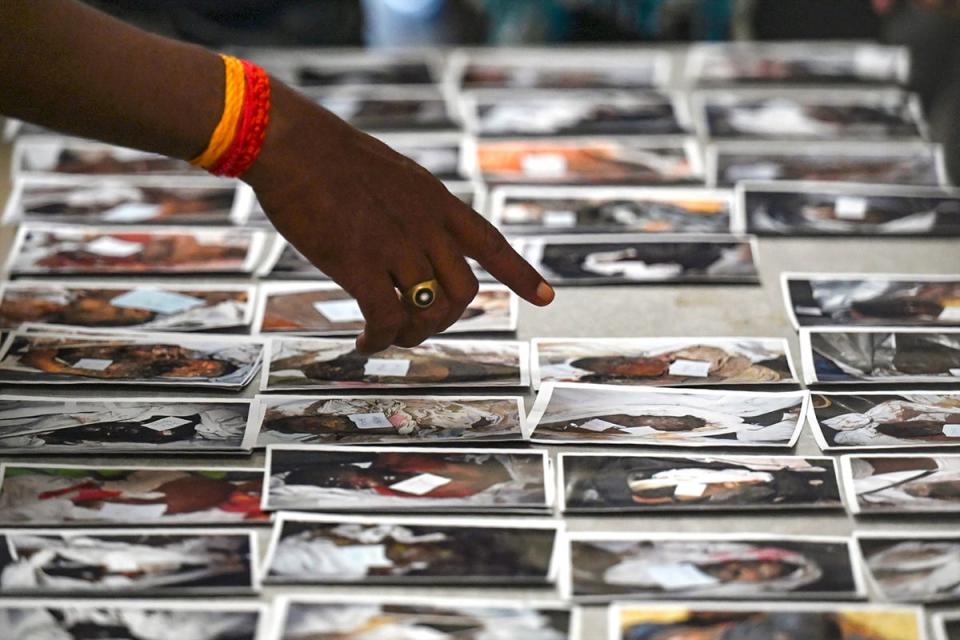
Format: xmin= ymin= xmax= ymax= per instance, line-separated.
xmin=240 ymin=42 xmax=910 ymax=93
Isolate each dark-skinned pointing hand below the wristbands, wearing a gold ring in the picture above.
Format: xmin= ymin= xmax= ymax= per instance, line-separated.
xmin=244 ymin=82 xmax=554 ymax=353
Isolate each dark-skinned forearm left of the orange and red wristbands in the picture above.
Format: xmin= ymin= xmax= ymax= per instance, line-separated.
xmin=0 ymin=0 xmax=224 ymax=159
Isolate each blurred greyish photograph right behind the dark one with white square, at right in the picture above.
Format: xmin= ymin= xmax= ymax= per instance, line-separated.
xmin=705 ymin=140 xmax=948 ymax=187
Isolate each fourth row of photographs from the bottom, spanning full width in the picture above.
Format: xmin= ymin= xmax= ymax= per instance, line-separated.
xmin=0 ymin=383 xmax=960 ymax=455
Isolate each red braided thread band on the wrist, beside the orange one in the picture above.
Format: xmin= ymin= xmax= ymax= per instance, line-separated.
xmin=210 ymin=60 xmax=270 ymax=178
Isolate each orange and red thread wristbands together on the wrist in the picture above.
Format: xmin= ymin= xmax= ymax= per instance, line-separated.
xmin=190 ymin=54 xmax=270 ymax=178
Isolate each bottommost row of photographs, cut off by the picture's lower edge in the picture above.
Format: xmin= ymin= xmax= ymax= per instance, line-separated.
xmin=0 ymin=595 xmax=948 ymax=640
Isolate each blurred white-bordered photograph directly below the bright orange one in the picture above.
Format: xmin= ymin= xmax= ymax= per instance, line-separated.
xmin=489 ymin=186 xmax=732 ymax=234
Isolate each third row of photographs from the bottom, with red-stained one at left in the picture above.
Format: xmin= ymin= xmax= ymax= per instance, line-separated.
xmin=0 ymin=445 xmax=960 ymax=526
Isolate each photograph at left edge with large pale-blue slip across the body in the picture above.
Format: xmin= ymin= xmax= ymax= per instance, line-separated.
xmin=0 ymin=280 xmax=256 ymax=331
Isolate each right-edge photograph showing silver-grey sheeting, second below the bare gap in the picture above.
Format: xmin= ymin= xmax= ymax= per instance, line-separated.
xmin=800 ymin=327 xmax=960 ymax=384
